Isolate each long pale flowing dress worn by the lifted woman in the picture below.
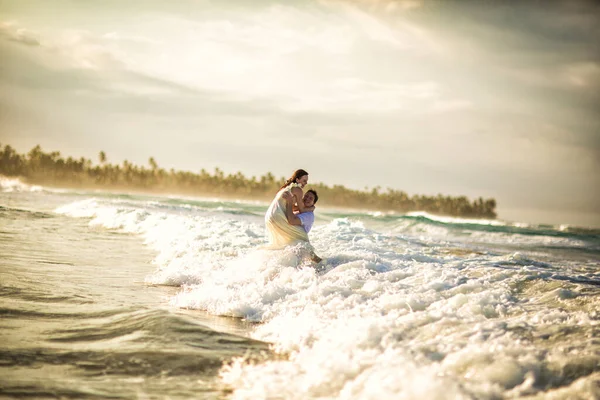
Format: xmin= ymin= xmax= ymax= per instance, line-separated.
xmin=265 ymin=183 xmax=309 ymax=249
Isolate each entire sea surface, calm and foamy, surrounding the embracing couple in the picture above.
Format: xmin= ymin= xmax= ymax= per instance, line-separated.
xmin=0 ymin=178 xmax=600 ymax=400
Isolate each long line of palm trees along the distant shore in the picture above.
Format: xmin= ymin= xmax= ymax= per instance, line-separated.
xmin=0 ymin=145 xmax=496 ymax=219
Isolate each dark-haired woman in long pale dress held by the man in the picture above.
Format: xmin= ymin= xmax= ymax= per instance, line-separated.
xmin=265 ymin=169 xmax=315 ymax=248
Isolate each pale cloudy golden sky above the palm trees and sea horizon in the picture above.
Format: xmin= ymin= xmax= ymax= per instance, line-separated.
xmin=0 ymin=0 xmax=600 ymax=227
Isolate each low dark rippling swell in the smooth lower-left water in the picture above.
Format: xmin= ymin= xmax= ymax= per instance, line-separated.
xmin=0 ymin=310 xmax=268 ymax=377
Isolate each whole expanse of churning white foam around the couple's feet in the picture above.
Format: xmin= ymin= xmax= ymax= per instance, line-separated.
xmin=52 ymin=195 xmax=600 ymax=400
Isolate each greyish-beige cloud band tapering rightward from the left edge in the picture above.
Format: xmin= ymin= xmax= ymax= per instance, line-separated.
xmin=0 ymin=43 xmax=275 ymax=119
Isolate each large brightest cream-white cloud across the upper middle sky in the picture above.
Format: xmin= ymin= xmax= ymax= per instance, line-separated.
xmin=0 ymin=5 xmax=454 ymax=114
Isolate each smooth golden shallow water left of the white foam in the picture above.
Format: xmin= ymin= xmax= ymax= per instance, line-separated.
xmin=0 ymin=183 xmax=268 ymax=399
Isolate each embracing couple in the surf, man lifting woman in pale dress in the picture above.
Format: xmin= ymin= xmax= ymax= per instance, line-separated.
xmin=265 ymin=169 xmax=321 ymax=263
